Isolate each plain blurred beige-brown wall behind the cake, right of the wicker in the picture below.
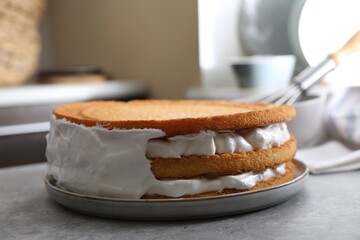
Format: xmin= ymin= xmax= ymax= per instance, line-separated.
xmin=40 ymin=0 xmax=200 ymax=98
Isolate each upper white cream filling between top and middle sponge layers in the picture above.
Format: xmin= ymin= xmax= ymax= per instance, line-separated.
xmin=146 ymin=123 xmax=290 ymax=158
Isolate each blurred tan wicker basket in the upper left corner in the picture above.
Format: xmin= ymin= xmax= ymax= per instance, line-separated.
xmin=0 ymin=0 xmax=45 ymax=86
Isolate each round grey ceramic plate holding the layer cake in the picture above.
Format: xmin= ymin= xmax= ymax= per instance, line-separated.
xmin=45 ymin=160 xmax=309 ymax=221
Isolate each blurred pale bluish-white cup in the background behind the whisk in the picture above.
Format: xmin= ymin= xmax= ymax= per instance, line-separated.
xmin=230 ymin=55 xmax=296 ymax=90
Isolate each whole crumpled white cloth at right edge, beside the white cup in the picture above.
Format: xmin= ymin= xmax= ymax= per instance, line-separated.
xmin=295 ymin=87 xmax=360 ymax=174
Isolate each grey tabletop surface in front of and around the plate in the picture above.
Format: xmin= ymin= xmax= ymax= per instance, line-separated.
xmin=0 ymin=163 xmax=360 ymax=240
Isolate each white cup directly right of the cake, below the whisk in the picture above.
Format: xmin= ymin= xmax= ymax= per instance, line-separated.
xmin=287 ymin=95 xmax=327 ymax=148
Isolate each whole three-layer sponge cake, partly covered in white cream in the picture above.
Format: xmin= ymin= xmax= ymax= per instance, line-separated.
xmin=46 ymin=100 xmax=296 ymax=199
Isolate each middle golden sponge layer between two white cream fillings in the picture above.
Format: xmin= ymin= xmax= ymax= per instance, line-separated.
xmin=150 ymin=136 xmax=296 ymax=179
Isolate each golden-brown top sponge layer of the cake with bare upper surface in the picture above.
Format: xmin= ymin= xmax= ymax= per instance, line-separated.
xmin=53 ymin=100 xmax=296 ymax=136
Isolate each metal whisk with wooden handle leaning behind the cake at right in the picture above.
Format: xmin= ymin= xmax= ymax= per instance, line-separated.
xmin=252 ymin=31 xmax=360 ymax=105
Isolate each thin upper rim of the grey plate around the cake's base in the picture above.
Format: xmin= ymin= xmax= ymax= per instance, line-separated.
xmin=44 ymin=159 xmax=309 ymax=204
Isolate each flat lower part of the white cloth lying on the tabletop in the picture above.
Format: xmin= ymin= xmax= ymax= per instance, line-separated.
xmin=295 ymin=140 xmax=360 ymax=174
